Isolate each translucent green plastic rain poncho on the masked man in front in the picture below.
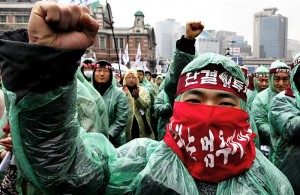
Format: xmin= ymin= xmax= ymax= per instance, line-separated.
xmin=0 ymin=29 xmax=293 ymax=195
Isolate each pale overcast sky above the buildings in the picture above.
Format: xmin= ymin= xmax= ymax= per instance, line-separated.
xmin=106 ymin=0 xmax=300 ymax=45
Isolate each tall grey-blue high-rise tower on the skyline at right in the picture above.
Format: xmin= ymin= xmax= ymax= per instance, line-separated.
xmin=253 ymin=8 xmax=288 ymax=59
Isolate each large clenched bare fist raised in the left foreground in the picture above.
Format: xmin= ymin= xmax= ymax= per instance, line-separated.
xmin=28 ymin=1 xmax=99 ymax=49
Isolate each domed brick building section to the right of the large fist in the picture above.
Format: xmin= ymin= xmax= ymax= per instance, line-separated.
xmin=92 ymin=5 xmax=156 ymax=71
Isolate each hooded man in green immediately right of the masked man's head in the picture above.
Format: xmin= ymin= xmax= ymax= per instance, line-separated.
xmin=247 ymin=65 xmax=269 ymax=110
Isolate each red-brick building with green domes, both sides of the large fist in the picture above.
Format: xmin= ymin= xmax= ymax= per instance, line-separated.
xmin=0 ymin=0 xmax=156 ymax=71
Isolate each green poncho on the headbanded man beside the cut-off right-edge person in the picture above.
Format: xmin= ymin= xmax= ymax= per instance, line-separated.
xmin=251 ymin=60 xmax=289 ymax=150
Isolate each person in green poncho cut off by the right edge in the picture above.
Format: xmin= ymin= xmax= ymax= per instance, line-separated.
xmin=269 ymin=53 xmax=300 ymax=194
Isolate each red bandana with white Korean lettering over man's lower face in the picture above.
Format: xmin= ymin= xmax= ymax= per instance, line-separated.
xmin=164 ymin=102 xmax=256 ymax=182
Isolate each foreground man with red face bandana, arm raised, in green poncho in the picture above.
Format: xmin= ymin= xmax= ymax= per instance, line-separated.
xmin=0 ymin=1 xmax=293 ymax=195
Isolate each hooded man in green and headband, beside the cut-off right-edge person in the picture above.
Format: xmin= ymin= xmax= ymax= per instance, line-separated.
xmin=251 ymin=60 xmax=290 ymax=156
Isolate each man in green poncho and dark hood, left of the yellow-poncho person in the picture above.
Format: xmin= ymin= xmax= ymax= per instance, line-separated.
xmin=92 ymin=60 xmax=129 ymax=147
